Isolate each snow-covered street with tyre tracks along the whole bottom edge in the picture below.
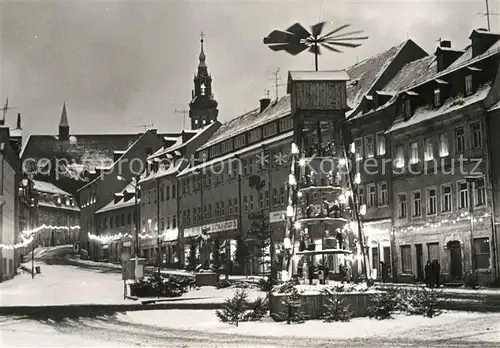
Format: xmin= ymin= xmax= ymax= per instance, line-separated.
xmin=0 ymin=311 xmax=500 ymax=348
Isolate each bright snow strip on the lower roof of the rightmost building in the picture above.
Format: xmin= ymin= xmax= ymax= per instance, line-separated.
xmin=386 ymin=84 xmax=491 ymax=133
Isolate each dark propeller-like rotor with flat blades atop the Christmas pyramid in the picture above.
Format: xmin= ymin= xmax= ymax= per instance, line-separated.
xmin=264 ymin=22 xmax=368 ymax=71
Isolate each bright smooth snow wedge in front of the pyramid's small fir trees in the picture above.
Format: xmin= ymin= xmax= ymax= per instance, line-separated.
xmin=119 ymin=310 xmax=500 ymax=345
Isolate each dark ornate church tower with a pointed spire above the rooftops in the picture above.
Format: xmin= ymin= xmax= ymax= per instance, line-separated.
xmin=189 ymin=32 xmax=219 ymax=130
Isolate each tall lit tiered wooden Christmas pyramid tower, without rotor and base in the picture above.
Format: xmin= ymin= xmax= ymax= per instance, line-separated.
xmin=282 ymin=71 xmax=370 ymax=282
